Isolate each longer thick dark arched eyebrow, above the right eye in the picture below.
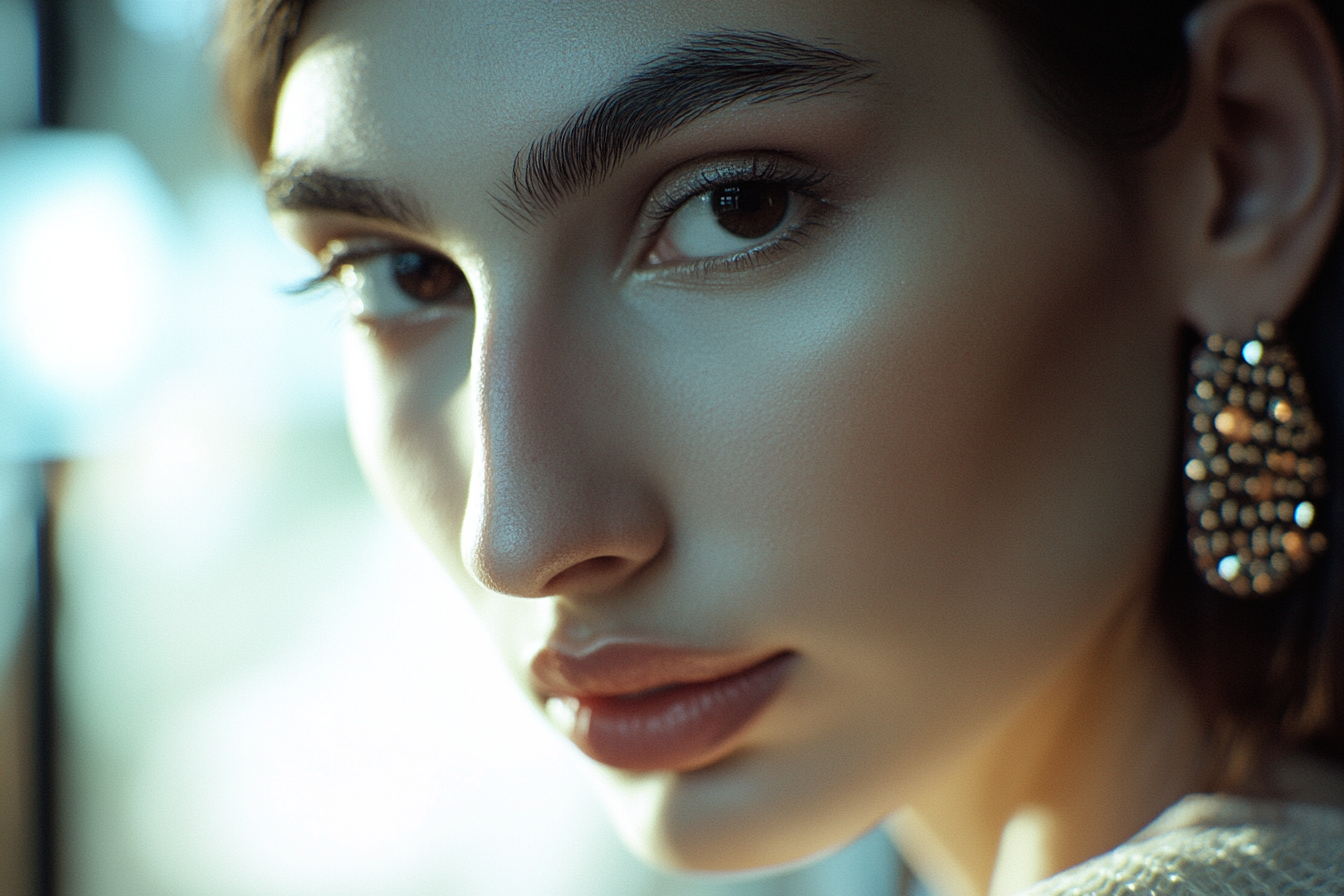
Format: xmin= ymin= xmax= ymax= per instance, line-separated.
xmin=492 ymin=31 xmax=876 ymax=226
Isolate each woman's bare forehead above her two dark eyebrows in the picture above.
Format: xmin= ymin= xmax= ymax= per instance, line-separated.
xmin=273 ymin=0 xmax=960 ymax=163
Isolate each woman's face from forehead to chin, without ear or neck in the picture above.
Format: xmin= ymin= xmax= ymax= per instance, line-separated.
xmin=271 ymin=0 xmax=1175 ymax=869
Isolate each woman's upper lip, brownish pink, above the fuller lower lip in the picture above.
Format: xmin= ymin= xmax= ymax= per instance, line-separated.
xmin=531 ymin=641 xmax=785 ymax=700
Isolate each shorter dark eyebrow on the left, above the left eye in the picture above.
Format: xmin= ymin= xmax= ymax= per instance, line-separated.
xmin=262 ymin=161 xmax=429 ymax=231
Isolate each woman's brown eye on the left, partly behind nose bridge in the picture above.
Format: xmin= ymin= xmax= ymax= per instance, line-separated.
xmin=320 ymin=244 xmax=472 ymax=324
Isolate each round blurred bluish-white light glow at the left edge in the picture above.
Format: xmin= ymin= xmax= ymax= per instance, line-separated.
xmin=0 ymin=132 xmax=173 ymax=458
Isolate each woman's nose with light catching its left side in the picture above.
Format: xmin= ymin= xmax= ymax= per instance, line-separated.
xmin=461 ymin=295 xmax=667 ymax=598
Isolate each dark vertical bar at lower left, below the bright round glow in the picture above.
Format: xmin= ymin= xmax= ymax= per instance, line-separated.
xmin=32 ymin=465 xmax=59 ymax=896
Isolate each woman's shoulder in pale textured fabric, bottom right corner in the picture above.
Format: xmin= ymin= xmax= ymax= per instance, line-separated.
xmin=1023 ymin=795 xmax=1344 ymax=896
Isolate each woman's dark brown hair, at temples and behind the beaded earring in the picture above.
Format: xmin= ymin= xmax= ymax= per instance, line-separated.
xmin=222 ymin=0 xmax=1344 ymax=786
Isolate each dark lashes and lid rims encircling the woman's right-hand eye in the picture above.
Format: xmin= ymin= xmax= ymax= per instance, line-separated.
xmin=640 ymin=156 xmax=829 ymax=275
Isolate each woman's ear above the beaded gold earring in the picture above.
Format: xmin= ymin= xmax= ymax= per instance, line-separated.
xmin=1166 ymin=0 xmax=1344 ymax=337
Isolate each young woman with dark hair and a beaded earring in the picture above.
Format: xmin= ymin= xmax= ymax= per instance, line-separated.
xmin=227 ymin=0 xmax=1344 ymax=895
